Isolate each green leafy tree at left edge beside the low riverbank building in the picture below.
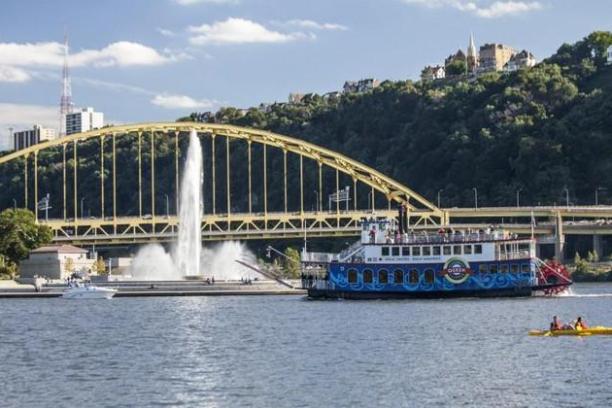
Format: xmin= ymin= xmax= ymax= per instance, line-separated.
xmin=0 ymin=208 xmax=52 ymax=265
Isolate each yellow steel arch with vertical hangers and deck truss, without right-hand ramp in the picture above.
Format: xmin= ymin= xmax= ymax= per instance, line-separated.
xmin=0 ymin=122 xmax=448 ymax=244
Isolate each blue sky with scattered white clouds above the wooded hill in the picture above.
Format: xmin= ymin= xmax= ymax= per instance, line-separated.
xmin=0 ymin=0 xmax=612 ymax=147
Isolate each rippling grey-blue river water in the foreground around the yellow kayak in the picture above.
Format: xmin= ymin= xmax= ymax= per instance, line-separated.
xmin=0 ymin=284 xmax=612 ymax=407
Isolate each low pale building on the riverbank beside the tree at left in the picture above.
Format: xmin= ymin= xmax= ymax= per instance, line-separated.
xmin=19 ymin=245 xmax=96 ymax=279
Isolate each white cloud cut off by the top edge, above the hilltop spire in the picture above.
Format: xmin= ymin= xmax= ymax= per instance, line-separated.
xmin=403 ymin=0 xmax=542 ymax=18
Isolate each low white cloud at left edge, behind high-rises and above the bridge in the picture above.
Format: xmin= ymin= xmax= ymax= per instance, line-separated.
xmin=0 ymin=102 xmax=60 ymax=150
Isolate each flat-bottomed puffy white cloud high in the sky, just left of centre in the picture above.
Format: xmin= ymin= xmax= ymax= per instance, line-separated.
xmin=188 ymin=17 xmax=306 ymax=45
